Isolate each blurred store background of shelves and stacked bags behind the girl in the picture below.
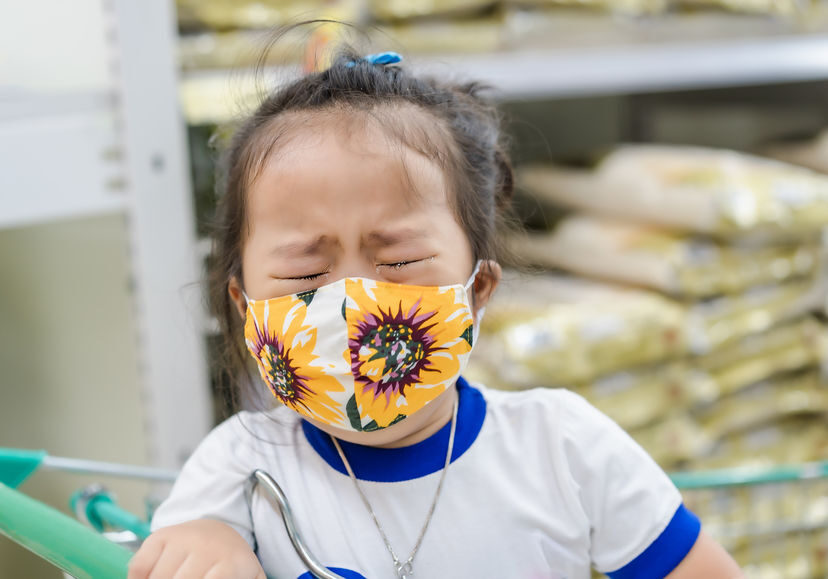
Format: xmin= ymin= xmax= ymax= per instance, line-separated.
xmin=0 ymin=0 xmax=828 ymax=579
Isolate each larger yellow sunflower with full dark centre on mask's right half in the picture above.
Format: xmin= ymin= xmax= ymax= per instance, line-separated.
xmin=343 ymin=279 xmax=472 ymax=428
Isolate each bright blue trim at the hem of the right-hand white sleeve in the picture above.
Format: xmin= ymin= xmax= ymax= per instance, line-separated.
xmin=607 ymin=505 xmax=701 ymax=579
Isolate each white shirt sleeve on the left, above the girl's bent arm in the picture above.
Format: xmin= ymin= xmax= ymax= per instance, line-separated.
xmin=152 ymin=416 xmax=255 ymax=549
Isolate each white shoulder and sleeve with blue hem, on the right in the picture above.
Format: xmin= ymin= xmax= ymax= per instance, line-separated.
xmin=475 ymin=385 xmax=698 ymax=577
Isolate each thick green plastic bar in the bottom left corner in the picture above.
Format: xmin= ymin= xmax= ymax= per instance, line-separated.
xmin=0 ymin=484 xmax=132 ymax=579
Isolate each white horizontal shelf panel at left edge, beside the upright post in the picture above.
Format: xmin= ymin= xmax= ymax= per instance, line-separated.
xmin=0 ymin=93 xmax=126 ymax=228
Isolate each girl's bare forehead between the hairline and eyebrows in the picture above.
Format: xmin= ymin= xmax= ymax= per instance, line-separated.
xmin=247 ymin=107 xmax=462 ymax=242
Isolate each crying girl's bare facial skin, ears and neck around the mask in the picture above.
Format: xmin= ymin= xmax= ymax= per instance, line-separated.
xmin=230 ymin=114 xmax=500 ymax=444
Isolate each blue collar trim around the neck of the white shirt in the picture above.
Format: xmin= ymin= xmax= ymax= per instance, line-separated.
xmin=302 ymin=377 xmax=486 ymax=482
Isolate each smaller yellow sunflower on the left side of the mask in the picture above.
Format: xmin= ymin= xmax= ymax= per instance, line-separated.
xmin=244 ymin=292 xmax=344 ymax=422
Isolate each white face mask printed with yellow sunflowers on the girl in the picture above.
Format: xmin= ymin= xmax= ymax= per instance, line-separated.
xmin=244 ymin=262 xmax=480 ymax=432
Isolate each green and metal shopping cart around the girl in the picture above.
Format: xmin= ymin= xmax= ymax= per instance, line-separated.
xmin=0 ymin=449 xmax=828 ymax=579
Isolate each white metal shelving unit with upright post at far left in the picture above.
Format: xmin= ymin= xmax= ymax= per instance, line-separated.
xmin=0 ymin=0 xmax=212 ymax=467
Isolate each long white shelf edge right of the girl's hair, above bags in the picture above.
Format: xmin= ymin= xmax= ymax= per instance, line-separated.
xmin=423 ymin=34 xmax=828 ymax=99
